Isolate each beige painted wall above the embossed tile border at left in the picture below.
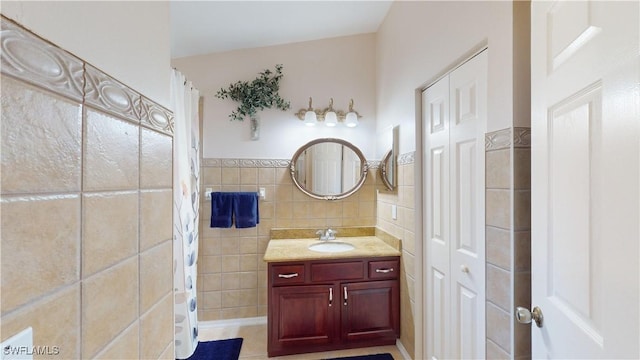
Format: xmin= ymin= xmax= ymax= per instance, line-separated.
xmin=0 ymin=1 xmax=171 ymax=107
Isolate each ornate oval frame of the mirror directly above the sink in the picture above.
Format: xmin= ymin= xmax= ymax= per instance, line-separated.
xmin=289 ymin=138 xmax=369 ymax=200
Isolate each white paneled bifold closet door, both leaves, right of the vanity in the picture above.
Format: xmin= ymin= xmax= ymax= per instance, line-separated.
xmin=422 ymin=50 xmax=487 ymax=359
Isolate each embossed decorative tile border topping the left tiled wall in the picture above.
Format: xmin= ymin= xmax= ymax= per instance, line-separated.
xmin=0 ymin=16 xmax=173 ymax=135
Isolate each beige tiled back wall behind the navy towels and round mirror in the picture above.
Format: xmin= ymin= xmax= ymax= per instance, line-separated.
xmin=198 ymin=159 xmax=376 ymax=321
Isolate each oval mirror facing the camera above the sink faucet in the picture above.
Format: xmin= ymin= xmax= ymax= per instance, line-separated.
xmin=289 ymin=138 xmax=369 ymax=200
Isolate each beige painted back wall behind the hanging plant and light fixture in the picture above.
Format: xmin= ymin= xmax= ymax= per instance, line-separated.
xmin=172 ymin=34 xmax=376 ymax=159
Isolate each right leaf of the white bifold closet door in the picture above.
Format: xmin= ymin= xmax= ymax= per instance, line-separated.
xmin=449 ymin=51 xmax=487 ymax=359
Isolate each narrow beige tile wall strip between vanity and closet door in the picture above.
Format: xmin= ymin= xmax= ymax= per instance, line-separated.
xmin=377 ymin=153 xmax=420 ymax=357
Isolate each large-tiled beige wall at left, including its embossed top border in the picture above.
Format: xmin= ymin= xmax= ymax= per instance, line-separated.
xmin=0 ymin=18 xmax=174 ymax=359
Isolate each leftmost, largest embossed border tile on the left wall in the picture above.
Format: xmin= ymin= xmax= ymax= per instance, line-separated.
xmin=0 ymin=17 xmax=84 ymax=102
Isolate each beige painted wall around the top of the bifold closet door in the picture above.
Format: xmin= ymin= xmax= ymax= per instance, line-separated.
xmin=376 ymin=1 xmax=528 ymax=154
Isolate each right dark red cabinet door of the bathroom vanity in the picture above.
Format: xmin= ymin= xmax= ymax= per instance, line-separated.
xmin=340 ymin=280 xmax=400 ymax=344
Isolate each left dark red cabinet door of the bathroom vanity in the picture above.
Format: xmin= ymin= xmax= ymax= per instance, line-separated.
xmin=268 ymin=285 xmax=341 ymax=356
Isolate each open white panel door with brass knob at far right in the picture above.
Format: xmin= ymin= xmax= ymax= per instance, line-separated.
xmin=519 ymin=1 xmax=640 ymax=359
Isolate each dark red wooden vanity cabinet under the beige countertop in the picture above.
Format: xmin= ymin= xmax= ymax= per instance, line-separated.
xmin=267 ymin=257 xmax=400 ymax=356
